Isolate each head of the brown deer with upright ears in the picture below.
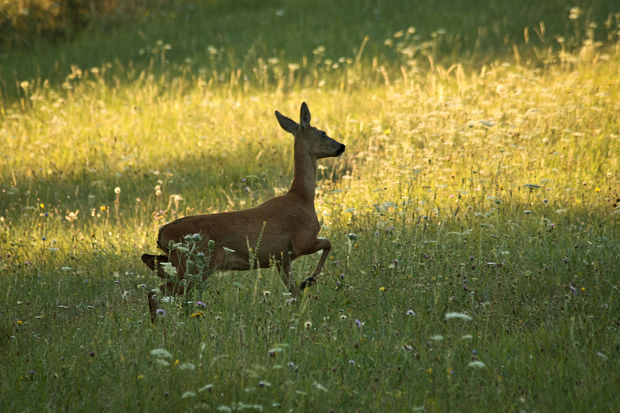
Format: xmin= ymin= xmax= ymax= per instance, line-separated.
xmin=276 ymin=102 xmax=345 ymax=159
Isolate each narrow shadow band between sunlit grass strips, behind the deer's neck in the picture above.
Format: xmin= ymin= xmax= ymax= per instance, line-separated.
xmin=0 ymin=137 xmax=354 ymax=228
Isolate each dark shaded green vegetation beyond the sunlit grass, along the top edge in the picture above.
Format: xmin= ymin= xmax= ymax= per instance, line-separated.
xmin=0 ymin=0 xmax=620 ymax=96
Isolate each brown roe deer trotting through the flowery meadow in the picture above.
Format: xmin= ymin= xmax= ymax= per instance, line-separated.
xmin=142 ymin=103 xmax=345 ymax=317
